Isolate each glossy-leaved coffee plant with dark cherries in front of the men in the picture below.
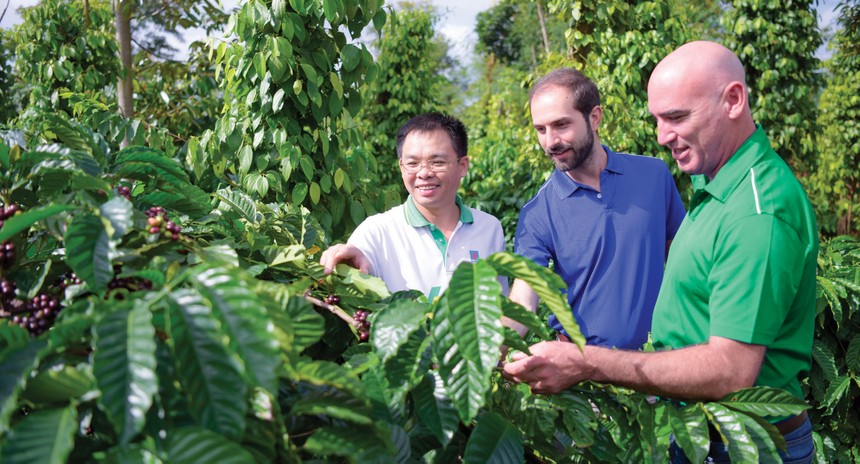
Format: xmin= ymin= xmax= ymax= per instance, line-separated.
xmin=0 ymin=125 xmax=805 ymax=463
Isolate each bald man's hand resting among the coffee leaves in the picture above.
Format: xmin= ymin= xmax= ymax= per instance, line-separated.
xmin=503 ymin=342 xmax=591 ymax=395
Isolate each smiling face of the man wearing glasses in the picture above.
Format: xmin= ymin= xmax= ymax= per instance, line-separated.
xmin=400 ymin=130 xmax=469 ymax=217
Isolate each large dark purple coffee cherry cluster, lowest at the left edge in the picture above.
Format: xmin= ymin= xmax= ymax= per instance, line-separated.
xmin=0 ymin=279 xmax=63 ymax=335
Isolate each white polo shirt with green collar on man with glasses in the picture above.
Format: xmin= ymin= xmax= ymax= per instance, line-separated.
xmin=348 ymin=196 xmax=508 ymax=300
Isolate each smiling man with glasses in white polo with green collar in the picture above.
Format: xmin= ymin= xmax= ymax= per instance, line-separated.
xmin=320 ymin=113 xmax=507 ymax=300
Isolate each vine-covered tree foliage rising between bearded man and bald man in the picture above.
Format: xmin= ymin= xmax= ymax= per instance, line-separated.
xmin=547 ymin=1 xmax=696 ymax=199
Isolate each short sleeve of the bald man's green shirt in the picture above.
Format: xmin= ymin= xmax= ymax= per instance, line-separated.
xmin=708 ymin=214 xmax=805 ymax=345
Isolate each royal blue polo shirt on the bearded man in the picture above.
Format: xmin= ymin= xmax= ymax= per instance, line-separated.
xmin=514 ymin=146 xmax=685 ymax=349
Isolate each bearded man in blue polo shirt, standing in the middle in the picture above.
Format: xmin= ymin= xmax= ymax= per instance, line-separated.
xmin=507 ymin=68 xmax=684 ymax=349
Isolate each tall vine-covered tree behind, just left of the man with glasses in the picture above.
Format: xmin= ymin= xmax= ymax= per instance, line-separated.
xmin=194 ymin=0 xmax=388 ymax=237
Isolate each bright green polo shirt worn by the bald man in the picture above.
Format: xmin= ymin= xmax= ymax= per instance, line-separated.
xmin=652 ymin=126 xmax=818 ymax=398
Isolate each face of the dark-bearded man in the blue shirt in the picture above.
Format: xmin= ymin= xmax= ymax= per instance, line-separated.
xmin=531 ymin=86 xmax=602 ymax=172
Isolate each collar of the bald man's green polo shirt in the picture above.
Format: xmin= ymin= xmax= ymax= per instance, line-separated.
xmin=691 ymin=125 xmax=771 ymax=202
